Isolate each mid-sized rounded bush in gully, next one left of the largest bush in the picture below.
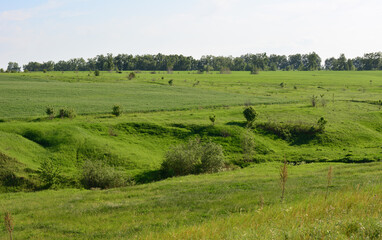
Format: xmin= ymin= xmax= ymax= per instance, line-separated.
xmin=80 ymin=160 xmax=126 ymax=189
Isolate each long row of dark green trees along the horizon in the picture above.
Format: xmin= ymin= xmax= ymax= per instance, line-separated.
xmin=3 ymin=52 xmax=382 ymax=72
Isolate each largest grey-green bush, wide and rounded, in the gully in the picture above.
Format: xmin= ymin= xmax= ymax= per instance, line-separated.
xmin=162 ymin=139 xmax=224 ymax=177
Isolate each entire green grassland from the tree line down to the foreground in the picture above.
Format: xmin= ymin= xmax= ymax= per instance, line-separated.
xmin=0 ymin=71 xmax=382 ymax=239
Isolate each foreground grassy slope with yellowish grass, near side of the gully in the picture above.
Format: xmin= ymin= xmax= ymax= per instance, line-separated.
xmin=0 ymin=163 xmax=382 ymax=239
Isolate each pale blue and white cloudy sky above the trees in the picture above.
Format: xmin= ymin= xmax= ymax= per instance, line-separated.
xmin=0 ymin=0 xmax=382 ymax=68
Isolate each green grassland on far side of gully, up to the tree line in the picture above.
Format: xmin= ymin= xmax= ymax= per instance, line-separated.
xmin=0 ymin=72 xmax=382 ymax=190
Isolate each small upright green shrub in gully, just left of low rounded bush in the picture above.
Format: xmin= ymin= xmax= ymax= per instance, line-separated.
xmin=38 ymin=160 xmax=61 ymax=188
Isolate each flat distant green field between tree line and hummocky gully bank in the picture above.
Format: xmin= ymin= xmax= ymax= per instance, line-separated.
xmin=0 ymin=71 xmax=382 ymax=119
